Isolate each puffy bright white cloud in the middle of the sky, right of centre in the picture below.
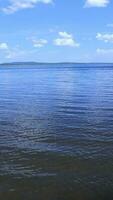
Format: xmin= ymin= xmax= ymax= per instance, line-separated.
xmin=54 ymin=32 xmax=80 ymax=47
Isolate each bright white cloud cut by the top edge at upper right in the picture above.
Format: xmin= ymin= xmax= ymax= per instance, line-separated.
xmin=85 ymin=0 xmax=110 ymax=7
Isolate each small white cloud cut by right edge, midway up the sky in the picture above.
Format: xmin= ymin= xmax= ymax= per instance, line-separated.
xmin=96 ymin=33 xmax=113 ymax=42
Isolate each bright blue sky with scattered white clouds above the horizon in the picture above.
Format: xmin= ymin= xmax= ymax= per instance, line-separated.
xmin=0 ymin=0 xmax=113 ymax=63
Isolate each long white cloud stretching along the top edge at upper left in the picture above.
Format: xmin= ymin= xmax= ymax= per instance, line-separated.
xmin=2 ymin=0 xmax=52 ymax=14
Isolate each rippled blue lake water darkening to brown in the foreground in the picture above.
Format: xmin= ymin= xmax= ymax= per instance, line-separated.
xmin=0 ymin=64 xmax=113 ymax=200
